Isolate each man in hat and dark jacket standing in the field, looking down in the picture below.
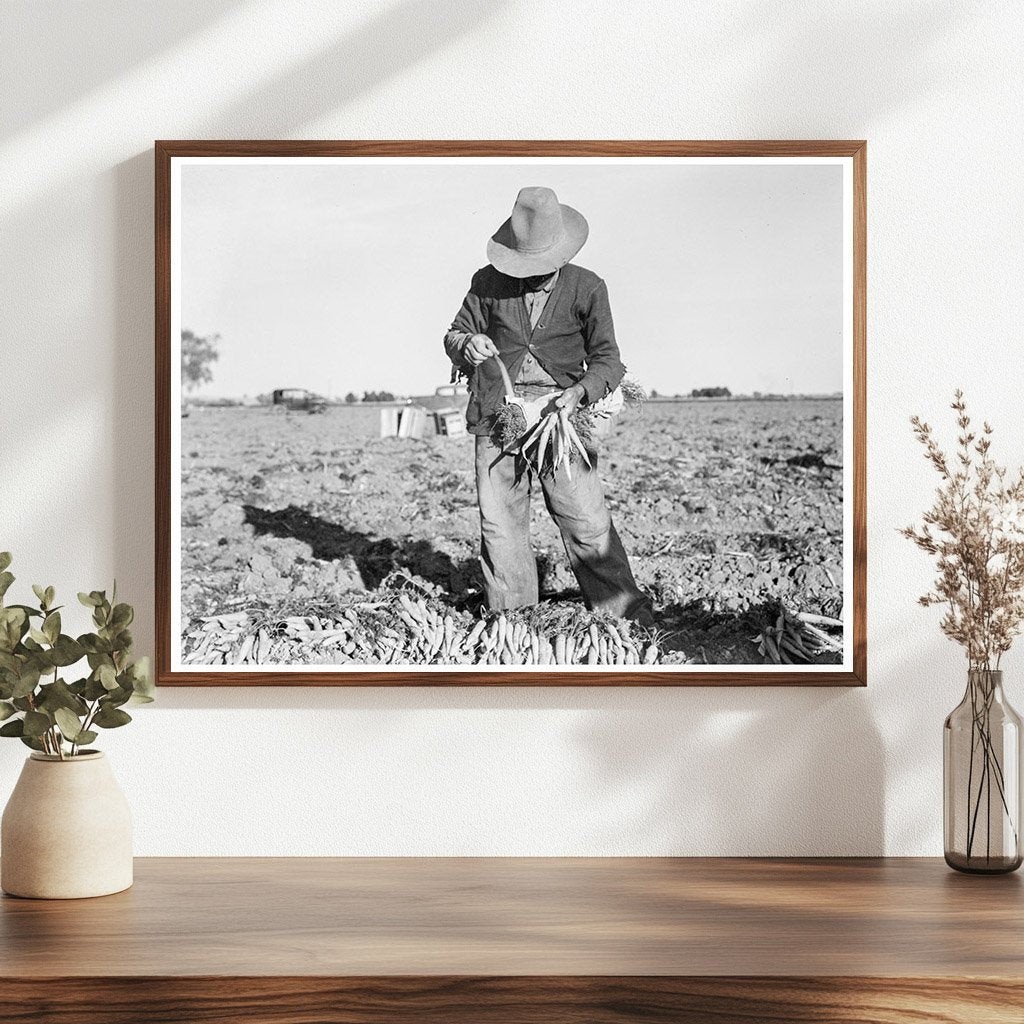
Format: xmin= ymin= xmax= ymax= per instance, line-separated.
xmin=444 ymin=187 xmax=652 ymax=625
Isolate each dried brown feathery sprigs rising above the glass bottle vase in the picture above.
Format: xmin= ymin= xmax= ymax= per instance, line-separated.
xmin=900 ymin=389 xmax=1024 ymax=671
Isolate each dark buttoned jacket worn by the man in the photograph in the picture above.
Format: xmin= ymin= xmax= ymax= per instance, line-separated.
xmin=445 ymin=263 xmax=626 ymax=434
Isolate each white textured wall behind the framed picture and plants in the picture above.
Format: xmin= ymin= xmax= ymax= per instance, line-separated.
xmin=0 ymin=0 xmax=1024 ymax=854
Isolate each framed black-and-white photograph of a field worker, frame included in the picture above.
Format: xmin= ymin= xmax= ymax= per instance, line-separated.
xmin=156 ymin=141 xmax=866 ymax=686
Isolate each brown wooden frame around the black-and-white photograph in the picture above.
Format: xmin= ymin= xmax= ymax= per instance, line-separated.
xmin=154 ymin=139 xmax=867 ymax=686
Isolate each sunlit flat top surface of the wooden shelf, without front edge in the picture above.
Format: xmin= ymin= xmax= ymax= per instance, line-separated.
xmin=8 ymin=857 xmax=1024 ymax=978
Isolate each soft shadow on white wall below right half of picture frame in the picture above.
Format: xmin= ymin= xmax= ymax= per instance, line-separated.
xmin=574 ymin=687 xmax=885 ymax=856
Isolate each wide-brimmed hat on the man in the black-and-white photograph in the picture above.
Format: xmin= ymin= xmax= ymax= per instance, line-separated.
xmin=487 ymin=185 xmax=590 ymax=278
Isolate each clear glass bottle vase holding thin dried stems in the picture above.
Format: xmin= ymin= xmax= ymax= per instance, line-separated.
xmin=942 ymin=669 xmax=1021 ymax=874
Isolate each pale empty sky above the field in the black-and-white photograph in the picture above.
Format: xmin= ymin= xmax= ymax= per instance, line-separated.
xmin=181 ymin=162 xmax=843 ymax=395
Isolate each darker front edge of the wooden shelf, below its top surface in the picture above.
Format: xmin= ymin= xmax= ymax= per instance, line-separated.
xmin=0 ymin=975 xmax=1024 ymax=1024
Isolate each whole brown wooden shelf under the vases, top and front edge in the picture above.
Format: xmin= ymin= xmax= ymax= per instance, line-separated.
xmin=0 ymin=858 xmax=1024 ymax=1024
